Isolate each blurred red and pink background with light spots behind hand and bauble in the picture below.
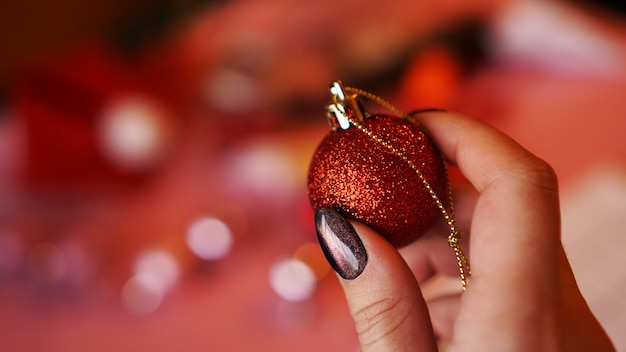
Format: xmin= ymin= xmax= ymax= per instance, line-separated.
xmin=0 ymin=0 xmax=626 ymax=352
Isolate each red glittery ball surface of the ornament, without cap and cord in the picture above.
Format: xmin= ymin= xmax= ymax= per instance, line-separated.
xmin=308 ymin=115 xmax=448 ymax=247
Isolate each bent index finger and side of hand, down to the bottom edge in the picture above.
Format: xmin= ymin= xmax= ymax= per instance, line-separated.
xmin=410 ymin=113 xmax=611 ymax=350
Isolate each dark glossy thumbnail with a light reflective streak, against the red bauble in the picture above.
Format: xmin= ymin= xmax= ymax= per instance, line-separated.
xmin=315 ymin=208 xmax=367 ymax=280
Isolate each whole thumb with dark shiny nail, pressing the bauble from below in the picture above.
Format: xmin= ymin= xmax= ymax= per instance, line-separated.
xmin=315 ymin=208 xmax=437 ymax=352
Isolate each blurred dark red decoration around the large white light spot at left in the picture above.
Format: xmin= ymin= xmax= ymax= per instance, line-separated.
xmin=13 ymin=46 xmax=181 ymax=189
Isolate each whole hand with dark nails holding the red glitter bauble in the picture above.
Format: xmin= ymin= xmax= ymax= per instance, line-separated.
xmin=316 ymin=112 xmax=614 ymax=352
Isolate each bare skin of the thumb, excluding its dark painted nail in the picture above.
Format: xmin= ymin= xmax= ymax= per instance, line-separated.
xmin=341 ymin=222 xmax=437 ymax=351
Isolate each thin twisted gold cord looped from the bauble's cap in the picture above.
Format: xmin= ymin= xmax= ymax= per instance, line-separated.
xmin=343 ymin=87 xmax=471 ymax=290
